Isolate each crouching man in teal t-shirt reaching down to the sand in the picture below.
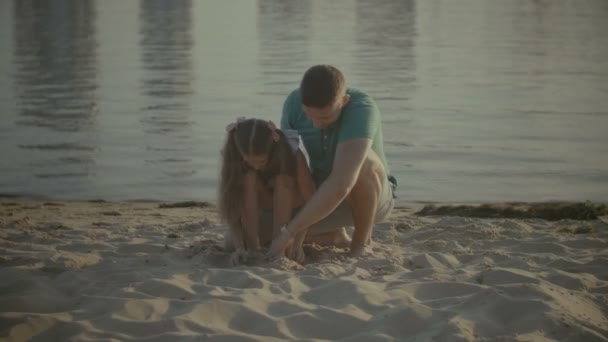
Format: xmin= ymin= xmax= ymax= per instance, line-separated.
xmin=269 ymin=65 xmax=397 ymax=256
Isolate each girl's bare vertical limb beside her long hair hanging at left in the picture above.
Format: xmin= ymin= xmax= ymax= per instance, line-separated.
xmin=241 ymin=171 xmax=260 ymax=251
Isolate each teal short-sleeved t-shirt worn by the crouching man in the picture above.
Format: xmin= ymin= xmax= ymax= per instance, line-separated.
xmin=281 ymin=88 xmax=397 ymax=195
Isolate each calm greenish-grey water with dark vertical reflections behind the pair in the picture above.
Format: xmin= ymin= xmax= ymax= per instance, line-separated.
xmin=0 ymin=0 xmax=608 ymax=202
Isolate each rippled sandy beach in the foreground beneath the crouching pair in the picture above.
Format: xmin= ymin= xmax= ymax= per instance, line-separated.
xmin=0 ymin=198 xmax=608 ymax=341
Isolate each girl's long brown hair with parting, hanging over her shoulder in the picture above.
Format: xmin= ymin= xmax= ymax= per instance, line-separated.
xmin=218 ymin=119 xmax=297 ymax=227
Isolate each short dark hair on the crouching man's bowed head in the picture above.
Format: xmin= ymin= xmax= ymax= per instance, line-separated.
xmin=300 ymin=65 xmax=344 ymax=108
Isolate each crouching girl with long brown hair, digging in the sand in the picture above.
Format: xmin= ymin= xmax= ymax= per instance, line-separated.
xmin=218 ymin=118 xmax=314 ymax=264
